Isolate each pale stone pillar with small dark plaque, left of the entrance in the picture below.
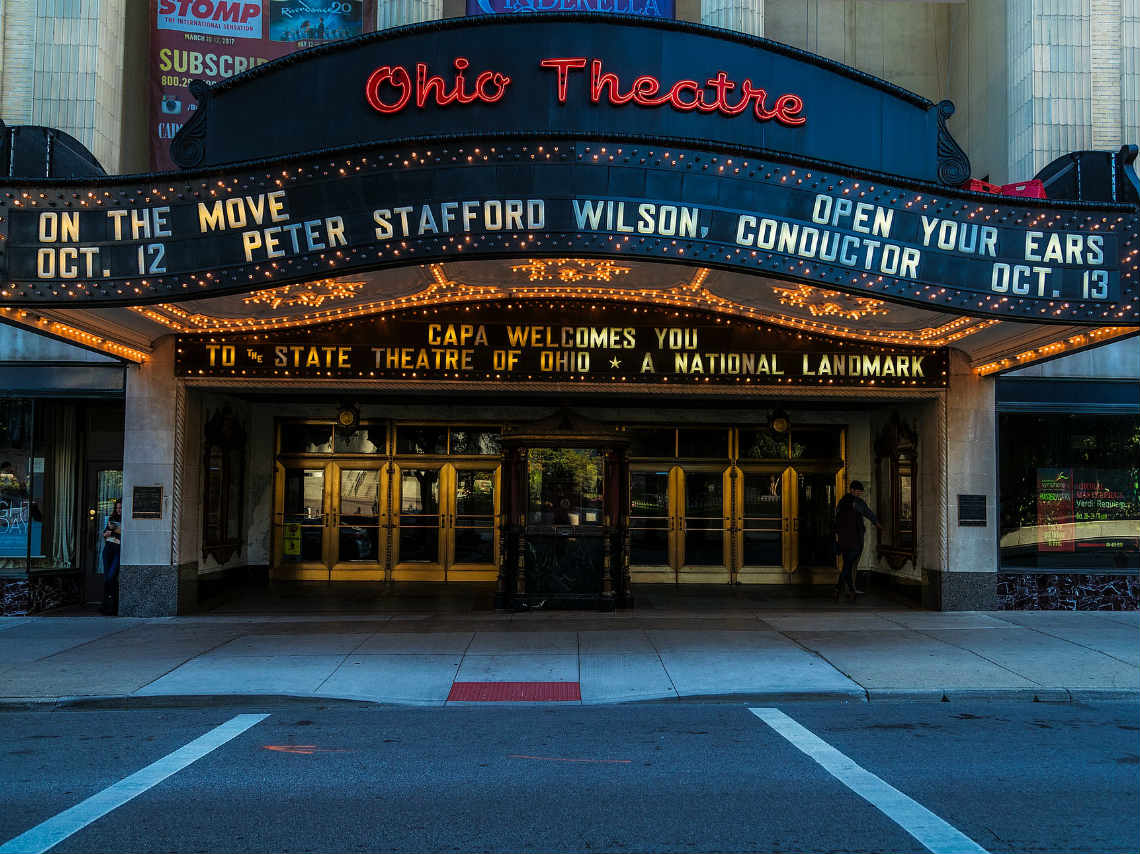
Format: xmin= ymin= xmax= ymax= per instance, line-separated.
xmin=119 ymin=336 xmax=188 ymax=617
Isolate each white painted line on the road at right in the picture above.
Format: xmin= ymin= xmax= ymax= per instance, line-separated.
xmin=749 ymin=709 xmax=987 ymax=854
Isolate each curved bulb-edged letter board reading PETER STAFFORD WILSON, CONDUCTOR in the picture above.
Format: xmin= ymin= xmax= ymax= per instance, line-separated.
xmin=0 ymin=140 xmax=1140 ymax=324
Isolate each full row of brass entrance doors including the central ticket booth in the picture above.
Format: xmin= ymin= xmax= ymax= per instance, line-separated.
xmin=271 ymin=421 xmax=846 ymax=601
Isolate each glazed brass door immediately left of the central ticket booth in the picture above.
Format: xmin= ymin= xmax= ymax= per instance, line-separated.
xmin=447 ymin=467 xmax=498 ymax=580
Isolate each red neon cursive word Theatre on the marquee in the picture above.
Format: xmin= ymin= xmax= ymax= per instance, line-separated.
xmin=538 ymin=57 xmax=807 ymax=127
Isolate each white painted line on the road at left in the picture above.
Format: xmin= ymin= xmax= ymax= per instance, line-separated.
xmin=0 ymin=715 xmax=269 ymax=854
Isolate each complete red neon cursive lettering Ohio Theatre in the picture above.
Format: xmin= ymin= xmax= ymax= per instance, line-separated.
xmin=364 ymin=56 xmax=807 ymax=128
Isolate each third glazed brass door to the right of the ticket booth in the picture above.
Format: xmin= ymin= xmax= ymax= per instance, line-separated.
xmin=733 ymin=465 xmax=797 ymax=584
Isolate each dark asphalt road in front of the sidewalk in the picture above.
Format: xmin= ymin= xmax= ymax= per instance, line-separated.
xmin=0 ymin=701 xmax=1140 ymax=852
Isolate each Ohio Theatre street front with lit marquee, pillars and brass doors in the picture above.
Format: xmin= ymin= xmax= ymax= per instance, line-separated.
xmin=0 ymin=15 xmax=1140 ymax=615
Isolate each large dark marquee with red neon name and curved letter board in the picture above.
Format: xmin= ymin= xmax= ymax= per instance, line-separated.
xmin=0 ymin=15 xmax=1140 ymax=325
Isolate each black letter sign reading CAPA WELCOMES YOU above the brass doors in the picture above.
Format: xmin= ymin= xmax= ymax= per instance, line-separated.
xmin=174 ymin=301 xmax=947 ymax=389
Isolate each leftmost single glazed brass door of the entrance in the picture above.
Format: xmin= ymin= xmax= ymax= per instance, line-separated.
xmin=277 ymin=465 xmax=328 ymax=580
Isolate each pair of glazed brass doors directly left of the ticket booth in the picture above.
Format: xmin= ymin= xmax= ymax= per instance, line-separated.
xmin=392 ymin=461 xmax=499 ymax=581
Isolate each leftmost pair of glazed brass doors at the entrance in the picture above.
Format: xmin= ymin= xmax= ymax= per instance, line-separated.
xmin=274 ymin=459 xmax=388 ymax=581
